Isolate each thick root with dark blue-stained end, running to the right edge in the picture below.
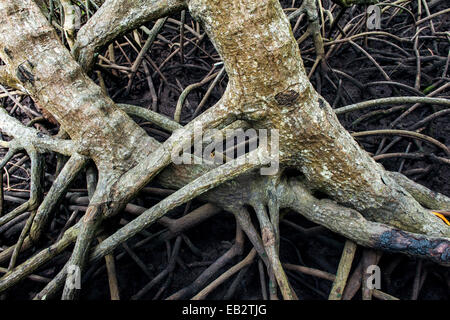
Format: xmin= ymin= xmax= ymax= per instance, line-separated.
xmin=282 ymin=180 xmax=450 ymax=265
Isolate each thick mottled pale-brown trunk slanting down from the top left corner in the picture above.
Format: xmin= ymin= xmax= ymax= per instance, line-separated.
xmin=0 ymin=0 xmax=156 ymax=170
